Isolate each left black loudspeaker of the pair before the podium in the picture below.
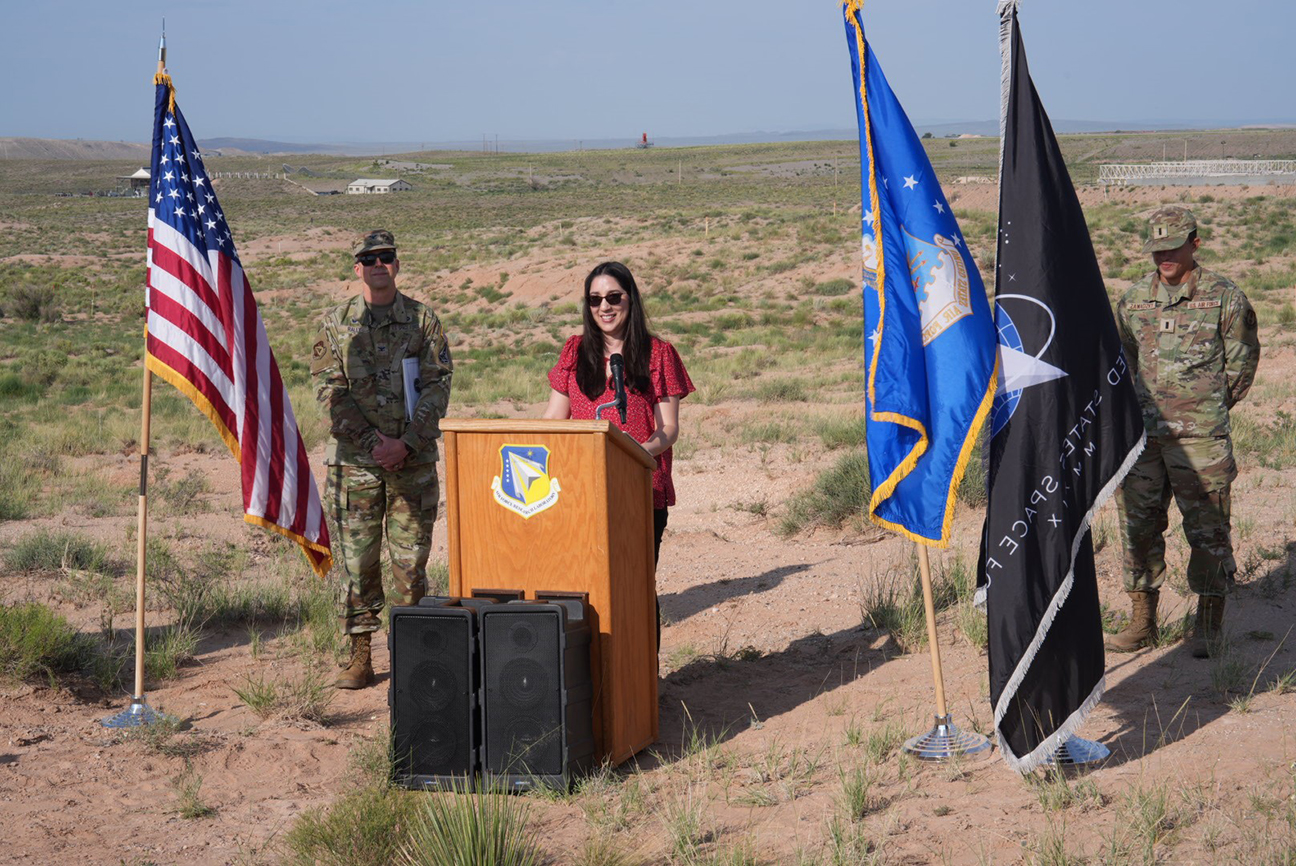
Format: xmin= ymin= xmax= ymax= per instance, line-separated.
xmin=388 ymin=598 xmax=490 ymax=790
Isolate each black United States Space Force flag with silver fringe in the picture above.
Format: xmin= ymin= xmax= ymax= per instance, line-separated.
xmin=977 ymin=0 xmax=1143 ymax=773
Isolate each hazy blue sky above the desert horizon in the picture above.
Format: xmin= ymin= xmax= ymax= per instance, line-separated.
xmin=0 ymin=0 xmax=1296 ymax=143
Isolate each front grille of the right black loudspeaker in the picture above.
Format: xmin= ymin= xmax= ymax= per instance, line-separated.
xmin=482 ymin=605 xmax=564 ymax=775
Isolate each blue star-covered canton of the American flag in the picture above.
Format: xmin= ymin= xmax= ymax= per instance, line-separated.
xmin=149 ymin=92 xmax=238 ymax=261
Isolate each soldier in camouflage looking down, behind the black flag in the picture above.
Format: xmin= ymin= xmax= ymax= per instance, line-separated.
xmin=1107 ymin=206 xmax=1260 ymax=659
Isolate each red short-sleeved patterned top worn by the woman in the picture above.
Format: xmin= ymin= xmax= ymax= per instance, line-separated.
xmin=550 ymin=334 xmax=693 ymax=508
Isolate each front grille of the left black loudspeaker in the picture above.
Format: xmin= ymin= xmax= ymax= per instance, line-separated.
xmin=391 ymin=611 xmax=474 ymax=777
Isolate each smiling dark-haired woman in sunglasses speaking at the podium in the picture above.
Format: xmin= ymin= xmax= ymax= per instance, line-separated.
xmin=544 ymin=262 xmax=693 ymax=563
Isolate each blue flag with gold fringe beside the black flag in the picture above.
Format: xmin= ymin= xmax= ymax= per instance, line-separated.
xmin=842 ymin=0 xmax=995 ymax=547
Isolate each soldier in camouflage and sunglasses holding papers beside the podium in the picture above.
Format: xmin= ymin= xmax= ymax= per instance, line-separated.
xmin=311 ymin=231 xmax=452 ymax=688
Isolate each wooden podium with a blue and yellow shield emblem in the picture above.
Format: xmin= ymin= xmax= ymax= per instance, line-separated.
xmin=441 ymin=419 xmax=657 ymax=764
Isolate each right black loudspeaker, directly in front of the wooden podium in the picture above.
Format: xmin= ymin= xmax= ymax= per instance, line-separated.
xmin=481 ymin=599 xmax=594 ymax=791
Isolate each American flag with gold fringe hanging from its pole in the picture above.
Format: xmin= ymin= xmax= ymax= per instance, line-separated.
xmin=145 ymin=75 xmax=333 ymax=577
